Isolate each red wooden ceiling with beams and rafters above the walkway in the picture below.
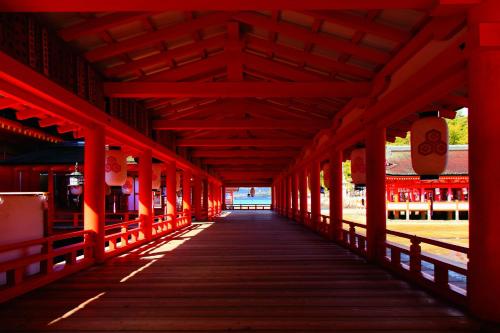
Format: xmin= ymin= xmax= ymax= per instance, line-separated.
xmin=0 ymin=1 xmax=468 ymax=184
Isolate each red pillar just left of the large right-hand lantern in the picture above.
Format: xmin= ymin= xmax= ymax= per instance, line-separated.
xmin=366 ymin=128 xmax=386 ymax=261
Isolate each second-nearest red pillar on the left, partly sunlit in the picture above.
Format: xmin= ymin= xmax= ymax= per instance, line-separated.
xmin=139 ymin=150 xmax=153 ymax=240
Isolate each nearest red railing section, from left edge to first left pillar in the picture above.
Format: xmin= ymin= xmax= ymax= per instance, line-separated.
xmin=0 ymin=231 xmax=94 ymax=302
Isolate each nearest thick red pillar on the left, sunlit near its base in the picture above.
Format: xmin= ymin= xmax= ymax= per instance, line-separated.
xmin=83 ymin=127 xmax=106 ymax=262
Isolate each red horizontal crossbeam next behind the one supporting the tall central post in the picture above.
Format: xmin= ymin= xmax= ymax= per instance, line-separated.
xmin=153 ymin=118 xmax=330 ymax=130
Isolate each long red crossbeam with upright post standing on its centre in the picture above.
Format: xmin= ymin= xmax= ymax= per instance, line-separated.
xmin=104 ymin=82 xmax=371 ymax=98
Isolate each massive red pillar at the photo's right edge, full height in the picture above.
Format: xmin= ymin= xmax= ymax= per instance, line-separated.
xmin=467 ymin=0 xmax=500 ymax=322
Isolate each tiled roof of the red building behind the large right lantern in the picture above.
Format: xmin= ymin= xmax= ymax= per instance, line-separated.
xmin=386 ymin=145 xmax=469 ymax=176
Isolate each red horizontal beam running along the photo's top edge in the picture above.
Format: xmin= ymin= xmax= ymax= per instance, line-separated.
xmin=0 ymin=0 xmax=438 ymax=12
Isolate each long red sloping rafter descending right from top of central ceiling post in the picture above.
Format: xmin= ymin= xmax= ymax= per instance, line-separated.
xmin=233 ymin=12 xmax=391 ymax=64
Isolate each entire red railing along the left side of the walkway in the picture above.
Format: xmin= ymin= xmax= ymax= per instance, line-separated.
xmin=0 ymin=212 xmax=191 ymax=303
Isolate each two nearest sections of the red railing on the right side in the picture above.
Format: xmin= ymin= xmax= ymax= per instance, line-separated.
xmin=341 ymin=221 xmax=468 ymax=304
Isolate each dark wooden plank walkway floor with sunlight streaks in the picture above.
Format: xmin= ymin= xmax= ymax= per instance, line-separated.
xmin=0 ymin=211 xmax=478 ymax=332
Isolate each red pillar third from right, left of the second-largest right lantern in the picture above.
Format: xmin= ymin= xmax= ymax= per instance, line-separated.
xmin=329 ymin=150 xmax=343 ymax=241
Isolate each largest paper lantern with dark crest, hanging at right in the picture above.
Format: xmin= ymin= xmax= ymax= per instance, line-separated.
xmin=411 ymin=117 xmax=448 ymax=176
